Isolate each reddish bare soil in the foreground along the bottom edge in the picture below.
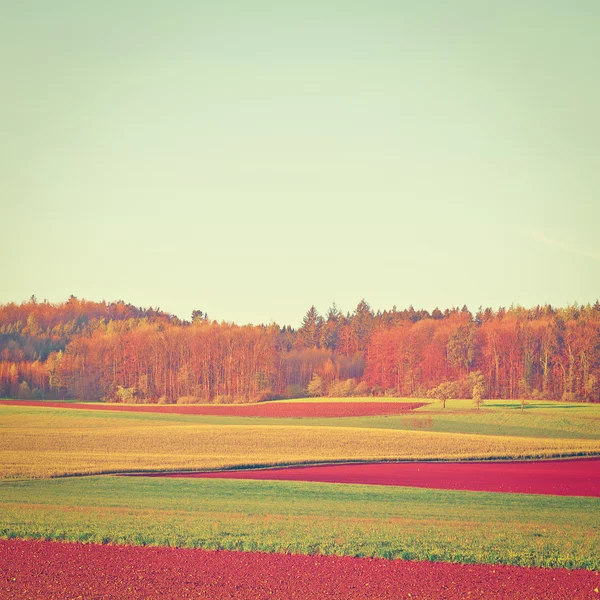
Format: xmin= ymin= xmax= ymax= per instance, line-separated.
xmin=0 ymin=540 xmax=600 ymax=600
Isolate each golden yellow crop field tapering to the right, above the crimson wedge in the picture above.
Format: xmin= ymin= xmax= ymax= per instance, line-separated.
xmin=0 ymin=409 xmax=600 ymax=478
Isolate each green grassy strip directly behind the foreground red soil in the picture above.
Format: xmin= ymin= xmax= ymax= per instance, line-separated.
xmin=0 ymin=477 xmax=600 ymax=569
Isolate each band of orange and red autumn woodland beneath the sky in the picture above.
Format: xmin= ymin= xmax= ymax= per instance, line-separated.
xmin=0 ymin=296 xmax=600 ymax=403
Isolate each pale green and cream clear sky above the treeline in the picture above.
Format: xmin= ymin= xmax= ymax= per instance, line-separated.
xmin=0 ymin=0 xmax=600 ymax=326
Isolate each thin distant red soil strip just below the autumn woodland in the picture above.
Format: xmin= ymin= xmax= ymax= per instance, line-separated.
xmin=0 ymin=400 xmax=426 ymax=418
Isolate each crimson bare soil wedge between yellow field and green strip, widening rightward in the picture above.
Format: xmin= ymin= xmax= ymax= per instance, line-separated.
xmin=142 ymin=458 xmax=600 ymax=497
